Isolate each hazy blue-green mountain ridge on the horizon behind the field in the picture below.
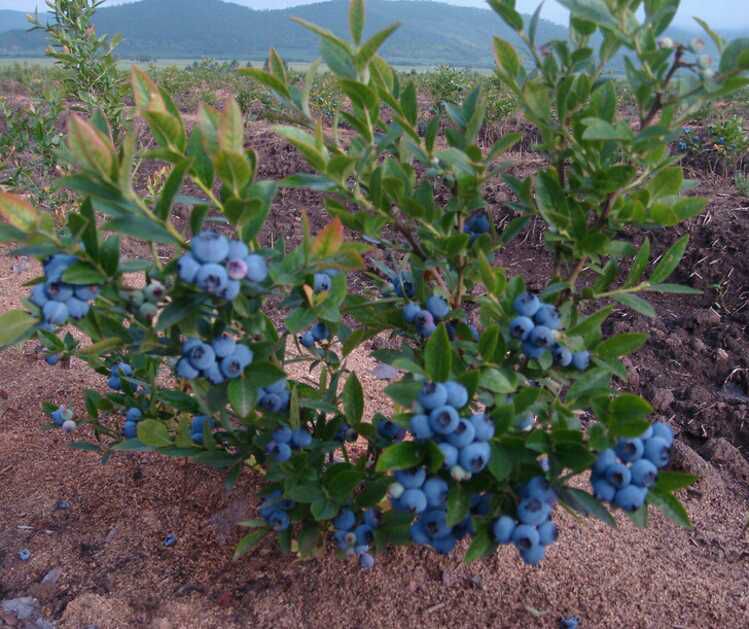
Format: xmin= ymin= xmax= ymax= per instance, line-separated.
xmin=0 ymin=0 xmax=566 ymax=66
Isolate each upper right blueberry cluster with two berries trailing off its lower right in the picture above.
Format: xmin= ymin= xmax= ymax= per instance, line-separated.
xmin=510 ymin=293 xmax=590 ymax=371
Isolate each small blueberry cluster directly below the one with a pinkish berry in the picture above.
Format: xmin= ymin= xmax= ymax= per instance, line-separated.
xmin=176 ymin=334 xmax=253 ymax=384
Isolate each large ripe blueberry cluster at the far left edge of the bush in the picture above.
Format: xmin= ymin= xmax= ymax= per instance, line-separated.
xmin=29 ymin=253 xmax=99 ymax=328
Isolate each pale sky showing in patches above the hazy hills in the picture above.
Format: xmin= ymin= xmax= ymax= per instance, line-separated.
xmin=0 ymin=0 xmax=749 ymax=28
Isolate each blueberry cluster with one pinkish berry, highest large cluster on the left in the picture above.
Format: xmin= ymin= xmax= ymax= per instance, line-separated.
xmin=177 ymin=230 xmax=268 ymax=301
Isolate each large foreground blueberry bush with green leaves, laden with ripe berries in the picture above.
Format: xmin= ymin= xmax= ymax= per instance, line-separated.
xmin=0 ymin=0 xmax=749 ymax=569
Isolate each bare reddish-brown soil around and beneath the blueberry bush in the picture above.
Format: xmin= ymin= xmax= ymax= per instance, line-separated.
xmin=0 ymin=123 xmax=749 ymax=629
